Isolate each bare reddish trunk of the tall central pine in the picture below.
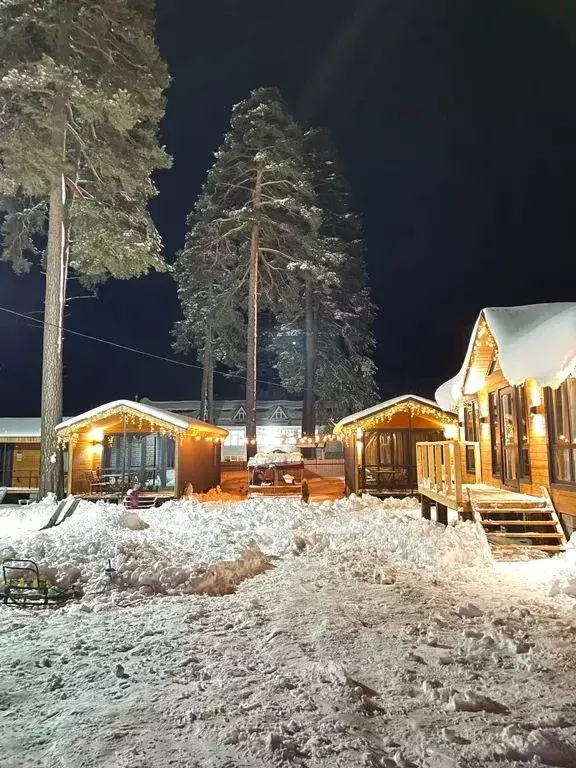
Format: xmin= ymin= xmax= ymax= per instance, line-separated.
xmin=246 ymin=168 xmax=262 ymax=458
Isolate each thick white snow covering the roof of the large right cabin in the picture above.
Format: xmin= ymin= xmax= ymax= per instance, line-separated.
xmin=436 ymin=302 xmax=576 ymax=410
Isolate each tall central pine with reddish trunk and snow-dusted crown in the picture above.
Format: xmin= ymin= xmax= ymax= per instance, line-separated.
xmin=180 ymin=88 xmax=318 ymax=455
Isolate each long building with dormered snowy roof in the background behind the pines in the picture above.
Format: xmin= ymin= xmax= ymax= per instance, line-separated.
xmin=141 ymin=397 xmax=337 ymax=461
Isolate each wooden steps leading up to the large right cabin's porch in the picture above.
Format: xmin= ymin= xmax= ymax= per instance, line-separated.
xmin=468 ymin=486 xmax=566 ymax=556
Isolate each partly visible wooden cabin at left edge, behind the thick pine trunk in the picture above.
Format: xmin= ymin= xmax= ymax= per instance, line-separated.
xmin=0 ymin=418 xmax=40 ymax=501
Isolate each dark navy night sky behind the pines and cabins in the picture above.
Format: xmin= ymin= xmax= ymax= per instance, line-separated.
xmin=0 ymin=0 xmax=576 ymax=416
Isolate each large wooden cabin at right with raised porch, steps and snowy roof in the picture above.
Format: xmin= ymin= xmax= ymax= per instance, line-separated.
xmin=418 ymin=303 xmax=576 ymax=550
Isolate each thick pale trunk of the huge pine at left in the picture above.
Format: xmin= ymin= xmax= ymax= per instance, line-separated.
xmin=38 ymin=174 xmax=68 ymax=498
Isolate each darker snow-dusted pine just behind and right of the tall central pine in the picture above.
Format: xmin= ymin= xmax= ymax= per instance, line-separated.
xmin=273 ymin=129 xmax=378 ymax=426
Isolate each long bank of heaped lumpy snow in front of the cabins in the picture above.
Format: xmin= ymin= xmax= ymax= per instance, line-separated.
xmin=0 ymin=496 xmax=491 ymax=594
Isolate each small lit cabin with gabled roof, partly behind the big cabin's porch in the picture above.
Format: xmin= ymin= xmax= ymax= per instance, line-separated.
xmin=334 ymin=395 xmax=458 ymax=496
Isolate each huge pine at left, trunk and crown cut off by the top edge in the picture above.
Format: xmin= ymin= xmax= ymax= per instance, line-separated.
xmin=0 ymin=0 xmax=169 ymax=495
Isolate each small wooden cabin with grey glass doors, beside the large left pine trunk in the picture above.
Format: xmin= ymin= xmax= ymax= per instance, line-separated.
xmin=56 ymin=400 xmax=228 ymax=498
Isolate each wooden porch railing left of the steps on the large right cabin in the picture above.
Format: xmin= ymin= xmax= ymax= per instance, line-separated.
xmin=416 ymin=440 xmax=482 ymax=507
